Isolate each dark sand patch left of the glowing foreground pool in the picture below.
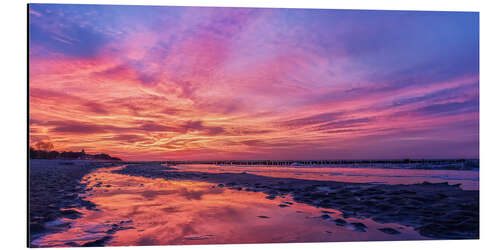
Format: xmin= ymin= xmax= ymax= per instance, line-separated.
xmin=28 ymin=160 xmax=121 ymax=247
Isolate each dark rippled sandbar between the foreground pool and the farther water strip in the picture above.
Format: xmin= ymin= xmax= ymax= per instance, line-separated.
xmin=114 ymin=164 xmax=479 ymax=239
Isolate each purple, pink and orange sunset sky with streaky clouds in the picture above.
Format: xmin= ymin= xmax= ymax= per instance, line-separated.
xmin=29 ymin=4 xmax=479 ymax=160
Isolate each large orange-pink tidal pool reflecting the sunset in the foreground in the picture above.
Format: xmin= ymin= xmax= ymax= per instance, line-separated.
xmin=33 ymin=165 xmax=425 ymax=246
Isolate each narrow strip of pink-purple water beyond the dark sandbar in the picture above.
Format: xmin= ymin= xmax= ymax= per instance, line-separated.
xmin=175 ymin=164 xmax=479 ymax=190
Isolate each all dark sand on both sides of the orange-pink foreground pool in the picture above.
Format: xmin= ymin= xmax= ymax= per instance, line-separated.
xmin=29 ymin=160 xmax=479 ymax=247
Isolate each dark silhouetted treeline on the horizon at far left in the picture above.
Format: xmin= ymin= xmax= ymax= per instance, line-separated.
xmin=30 ymin=147 xmax=121 ymax=161
